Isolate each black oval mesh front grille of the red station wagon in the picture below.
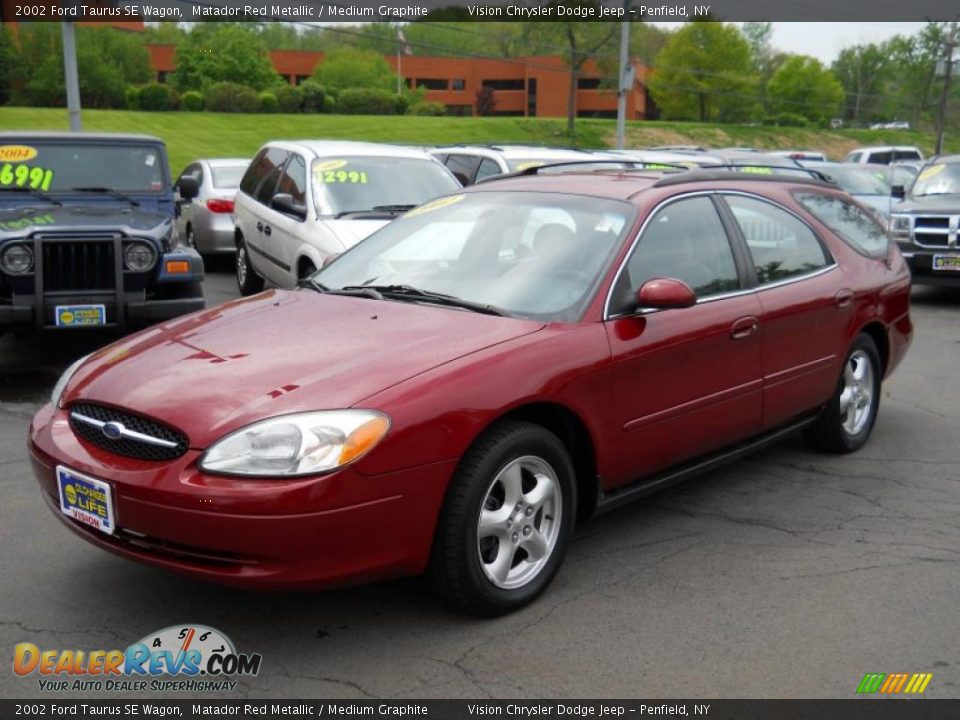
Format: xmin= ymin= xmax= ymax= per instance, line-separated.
xmin=70 ymin=403 xmax=188 ymax=460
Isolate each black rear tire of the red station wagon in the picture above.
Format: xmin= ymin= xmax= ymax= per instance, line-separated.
xmin=804 ymin=334 xmax=883 ymax=453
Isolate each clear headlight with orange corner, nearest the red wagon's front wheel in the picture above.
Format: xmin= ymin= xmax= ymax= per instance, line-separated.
xmin=200 ymin=410 xmax=390 ymax=477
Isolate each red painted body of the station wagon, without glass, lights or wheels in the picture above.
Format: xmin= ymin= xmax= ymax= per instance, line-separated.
xmin=30 ymin=173 xmax=912 ymax=588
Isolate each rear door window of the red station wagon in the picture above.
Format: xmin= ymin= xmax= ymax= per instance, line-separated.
xmin=724 ymin=195 xmax=832 ymax=285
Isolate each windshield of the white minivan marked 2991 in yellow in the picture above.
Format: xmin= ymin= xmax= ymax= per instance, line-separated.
xmin=312 ymin=156 xmax=460 ymax=216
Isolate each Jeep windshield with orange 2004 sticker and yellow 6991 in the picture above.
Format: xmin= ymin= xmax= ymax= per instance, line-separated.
xmin=0 ymin=139 xmax=166 ymax=193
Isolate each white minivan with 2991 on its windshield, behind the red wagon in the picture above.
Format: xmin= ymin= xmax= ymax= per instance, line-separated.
xmin=234 ymin=140 xmax=460 ymax=295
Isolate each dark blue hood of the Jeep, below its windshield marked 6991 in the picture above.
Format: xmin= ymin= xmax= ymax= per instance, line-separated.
xmin=0 ymin=203 xmax=171 ymax=240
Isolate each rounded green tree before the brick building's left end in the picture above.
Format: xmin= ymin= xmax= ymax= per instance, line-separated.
xmin=171 ymin=23 xmax=280 ymax=93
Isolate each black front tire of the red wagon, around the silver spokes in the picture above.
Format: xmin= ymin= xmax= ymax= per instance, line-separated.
xmin=427 ymin=420 xmax=577 ymax=617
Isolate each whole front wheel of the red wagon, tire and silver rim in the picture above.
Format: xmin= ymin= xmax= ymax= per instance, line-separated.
xmin=429 ymin=421 xmax=576 ymax=616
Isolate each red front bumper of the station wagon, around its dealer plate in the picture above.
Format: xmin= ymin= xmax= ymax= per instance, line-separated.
xmin=30 ymin=405 xmax=454 ymax=589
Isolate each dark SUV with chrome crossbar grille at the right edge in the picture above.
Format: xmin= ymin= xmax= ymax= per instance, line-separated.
xmin=890 ymin=155 xmax=960 ymax=286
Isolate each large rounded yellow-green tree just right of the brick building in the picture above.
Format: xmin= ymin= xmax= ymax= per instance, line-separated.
xmin=649 ymin=20 xmax=758 ymax=122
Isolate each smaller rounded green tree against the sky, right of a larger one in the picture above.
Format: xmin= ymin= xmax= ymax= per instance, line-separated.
xmin=767 ymin=55 xmax=843 ymax=122
